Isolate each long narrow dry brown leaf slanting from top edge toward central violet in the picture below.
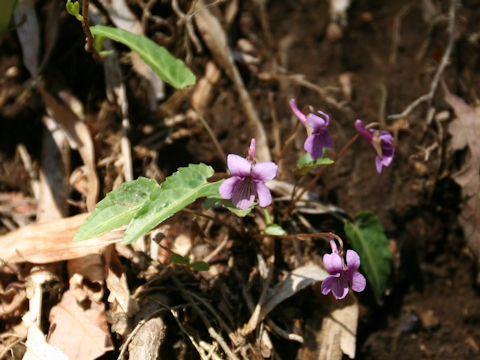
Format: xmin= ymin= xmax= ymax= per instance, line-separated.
xmin=195 ymin=0 xmax=271 ymax=161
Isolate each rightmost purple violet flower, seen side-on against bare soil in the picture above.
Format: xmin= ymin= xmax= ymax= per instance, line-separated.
xmin=355 ymin=120 xmax=395 ymax=174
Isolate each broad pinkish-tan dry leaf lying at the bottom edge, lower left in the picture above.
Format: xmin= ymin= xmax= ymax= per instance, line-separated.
xmin=48 ymin=290 xmax=114 ymax=360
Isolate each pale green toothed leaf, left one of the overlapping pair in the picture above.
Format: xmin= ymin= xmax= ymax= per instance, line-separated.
xmin=73 ymin=177 xmax=160 ymax=241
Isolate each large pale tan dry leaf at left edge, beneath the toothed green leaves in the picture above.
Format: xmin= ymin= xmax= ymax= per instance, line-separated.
xmin=0 ymin=213 xmax=124 ymax=264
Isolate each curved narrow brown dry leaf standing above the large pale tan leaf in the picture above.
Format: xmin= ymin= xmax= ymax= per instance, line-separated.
xmin=39 ymin=88 xmax=99 ymax=211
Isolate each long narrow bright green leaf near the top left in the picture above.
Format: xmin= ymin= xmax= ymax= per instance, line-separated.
xmin=90 ymin=25 xmax=196 ymax=89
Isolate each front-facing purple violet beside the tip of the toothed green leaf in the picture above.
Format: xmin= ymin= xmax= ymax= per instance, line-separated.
xmin=218 ymin=139 xmax=278 ymax=210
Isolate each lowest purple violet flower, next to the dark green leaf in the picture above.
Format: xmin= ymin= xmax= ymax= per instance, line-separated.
xmin=322 ymin=239 xmax=367 ymax=300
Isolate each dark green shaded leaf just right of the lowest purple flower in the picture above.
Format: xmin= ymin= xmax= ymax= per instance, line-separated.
xmin=345 ymin=212 xmax=391 ymax=303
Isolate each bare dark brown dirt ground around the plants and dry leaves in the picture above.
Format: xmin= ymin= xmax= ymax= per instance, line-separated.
xmin=0 ymin=0 xmax=480 ymax=360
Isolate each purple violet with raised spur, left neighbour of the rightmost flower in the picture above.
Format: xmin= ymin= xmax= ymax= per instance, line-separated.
xmin=290 ymin=99 xmax=333 ymax=160
